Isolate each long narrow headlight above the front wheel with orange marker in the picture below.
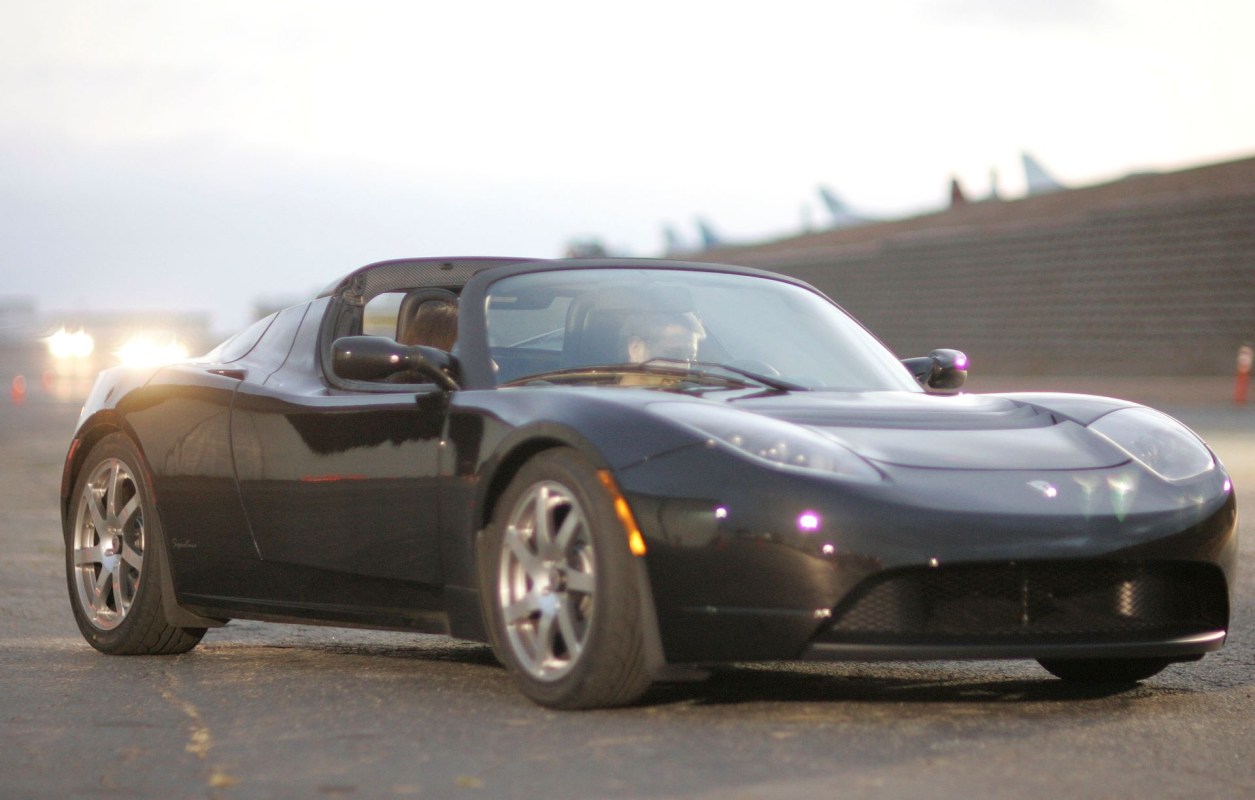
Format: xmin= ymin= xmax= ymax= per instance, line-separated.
xmin=650 ymin=402 xmax=881 ymax=481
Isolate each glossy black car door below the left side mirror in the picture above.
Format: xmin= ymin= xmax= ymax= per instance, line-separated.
xmin=231 ymin=297 xmax=446 ymax=605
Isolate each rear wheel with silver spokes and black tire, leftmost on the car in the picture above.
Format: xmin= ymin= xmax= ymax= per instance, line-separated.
xmin=65 ymin=433 xmax=205 ymax=656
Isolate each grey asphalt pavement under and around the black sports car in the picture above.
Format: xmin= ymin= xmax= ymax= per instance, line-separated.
xmin=0 ymin=398 xmax=1255 ymax=800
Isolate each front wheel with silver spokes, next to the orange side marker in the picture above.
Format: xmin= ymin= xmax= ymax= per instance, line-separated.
xmin=479 ymin=448 xmax=650 ymax=708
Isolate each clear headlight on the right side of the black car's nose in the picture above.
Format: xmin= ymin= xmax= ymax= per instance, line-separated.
xmin=1089 ymin=408 xmax=1216 ymax=481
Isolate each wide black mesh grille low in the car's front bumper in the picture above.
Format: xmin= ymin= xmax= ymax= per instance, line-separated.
xmin=818 ymin=561 xmax=1229 ymax=643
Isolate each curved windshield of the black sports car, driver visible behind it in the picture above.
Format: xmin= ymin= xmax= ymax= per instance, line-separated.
xmin=487 ymin=268 xmax=921 ymax=391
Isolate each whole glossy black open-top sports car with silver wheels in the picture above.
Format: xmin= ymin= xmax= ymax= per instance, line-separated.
xmin=61 ymin=253 xmax=1237 ymax=708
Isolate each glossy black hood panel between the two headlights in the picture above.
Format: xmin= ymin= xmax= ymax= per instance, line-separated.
xmin=730 ymin=392 xmax=1128 ymax=470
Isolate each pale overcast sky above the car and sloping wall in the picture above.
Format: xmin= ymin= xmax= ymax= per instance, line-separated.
xmin=0 ymin=0 xmax=1255 ymax=334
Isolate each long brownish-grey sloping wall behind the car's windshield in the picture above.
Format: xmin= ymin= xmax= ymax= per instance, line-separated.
xmin=694 ymin=158 xmax=1255 ymax=377
